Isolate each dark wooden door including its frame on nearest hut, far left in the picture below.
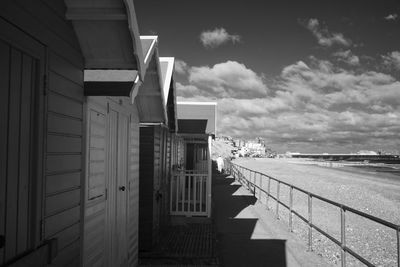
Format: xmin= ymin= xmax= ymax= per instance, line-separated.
xmin=0 ymin=18 xmax=45 ymax=265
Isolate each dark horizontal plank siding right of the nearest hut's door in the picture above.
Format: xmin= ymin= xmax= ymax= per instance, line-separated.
xmin=42 ymin=49 xmax=84 ymax=265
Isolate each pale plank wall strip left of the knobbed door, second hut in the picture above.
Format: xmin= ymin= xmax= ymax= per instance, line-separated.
xmin=83 ymin=98 xmax=108 ymax=266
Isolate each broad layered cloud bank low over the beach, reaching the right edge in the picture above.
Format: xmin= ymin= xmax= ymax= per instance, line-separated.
xmin=177 ymin=57 xmax=400 ymax=153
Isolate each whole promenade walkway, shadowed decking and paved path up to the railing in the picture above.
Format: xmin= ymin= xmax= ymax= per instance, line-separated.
xmin=140 ymin=172 xmax=330 ymax=267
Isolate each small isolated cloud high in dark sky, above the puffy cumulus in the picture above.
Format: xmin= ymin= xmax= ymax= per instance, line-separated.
xmin=200 ymin=28 xmax=241 ymax=48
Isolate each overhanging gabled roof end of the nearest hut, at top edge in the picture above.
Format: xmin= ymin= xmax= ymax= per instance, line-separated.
xmin=65 ymin=0 xmax=145 ymax=79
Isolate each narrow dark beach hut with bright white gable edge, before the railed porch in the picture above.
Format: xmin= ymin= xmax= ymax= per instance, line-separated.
xmin=139 ymin=57 xmax=177 ymax=251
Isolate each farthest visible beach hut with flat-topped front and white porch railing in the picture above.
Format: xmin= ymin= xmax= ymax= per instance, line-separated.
xmin=170 ymin=102 xmax=217 ymax=217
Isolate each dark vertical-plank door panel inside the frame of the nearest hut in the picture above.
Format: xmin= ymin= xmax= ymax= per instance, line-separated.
xmin=0 ymin=37 xmax=44 ymax=264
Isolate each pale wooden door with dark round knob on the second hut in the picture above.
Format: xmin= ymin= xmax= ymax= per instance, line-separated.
xmin=109 ymin=103 xmax=129 ymax=266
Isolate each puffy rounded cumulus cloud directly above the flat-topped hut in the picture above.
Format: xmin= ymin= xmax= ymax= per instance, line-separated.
xmin=180 ymin=61 xmax=267 ymax=98
